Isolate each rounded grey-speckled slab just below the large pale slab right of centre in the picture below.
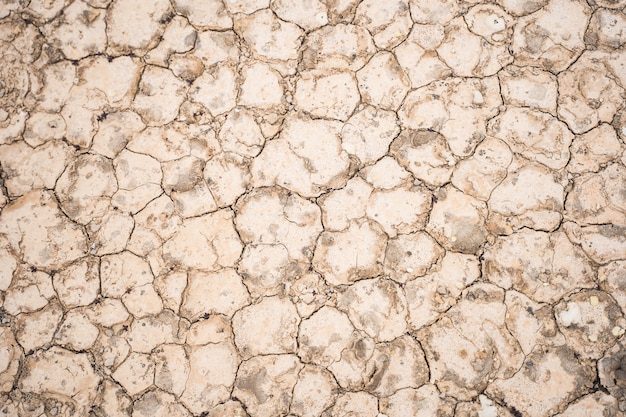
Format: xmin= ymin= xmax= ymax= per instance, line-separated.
xmin=337 ymin=278 xmax=406 ymax=342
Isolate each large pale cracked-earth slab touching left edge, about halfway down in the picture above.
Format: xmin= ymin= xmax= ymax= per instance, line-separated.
xmin=0 ymin=191 xmax=87 ymax=269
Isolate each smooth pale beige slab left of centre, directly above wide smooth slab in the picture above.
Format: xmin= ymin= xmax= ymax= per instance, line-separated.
xmin=163 ymin=209 xmax=243 ymax=271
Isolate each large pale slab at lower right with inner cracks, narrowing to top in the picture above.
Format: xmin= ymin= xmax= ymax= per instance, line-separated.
xmin=418 ymin=284 xmax=524 ymax=400
